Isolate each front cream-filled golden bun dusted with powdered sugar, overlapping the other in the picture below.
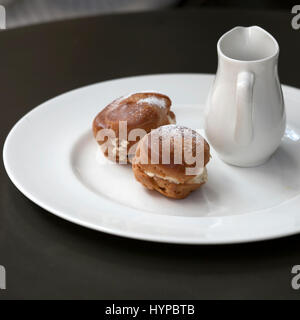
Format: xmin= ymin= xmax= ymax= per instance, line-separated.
xmin=132 ymin=125 xmax=210 ymax=199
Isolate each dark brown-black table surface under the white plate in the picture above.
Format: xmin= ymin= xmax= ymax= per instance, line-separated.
xmin=0 ymin=9 xmax=300 ymax=299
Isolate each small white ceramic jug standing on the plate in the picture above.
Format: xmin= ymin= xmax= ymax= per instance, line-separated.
xmin=205 ymin=26 xmax=286 ymax=167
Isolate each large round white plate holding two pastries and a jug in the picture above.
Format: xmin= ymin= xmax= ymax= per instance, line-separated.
xmin=3 ymin=74 xmax=300 ymax=244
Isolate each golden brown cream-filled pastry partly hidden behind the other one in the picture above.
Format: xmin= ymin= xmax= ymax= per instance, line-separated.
xmin=93 ymin=92 xmax=176 ymax=163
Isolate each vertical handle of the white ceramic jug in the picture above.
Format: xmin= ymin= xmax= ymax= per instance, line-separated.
xmin=234 ymin=71 xmax=254 ymax=146
